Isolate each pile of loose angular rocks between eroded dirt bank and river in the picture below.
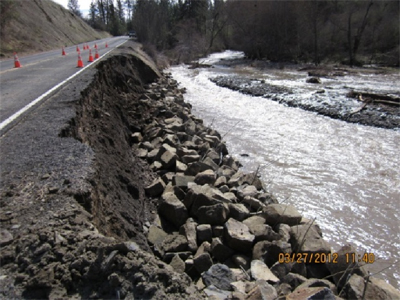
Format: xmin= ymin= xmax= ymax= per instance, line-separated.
xmin=132 ymin=76 xmax=400 ymax=299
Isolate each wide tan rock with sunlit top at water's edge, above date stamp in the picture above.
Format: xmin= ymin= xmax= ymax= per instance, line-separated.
xmin=263 ymin=204 xmax=302 ymax=227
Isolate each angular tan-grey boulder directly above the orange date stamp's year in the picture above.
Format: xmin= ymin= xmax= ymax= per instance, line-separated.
xmin=290 ymin=225 xmax=331 ymax=253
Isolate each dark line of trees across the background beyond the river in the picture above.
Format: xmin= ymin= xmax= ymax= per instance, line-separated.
xmin=70 ymin=0 xmax=400 ymax=66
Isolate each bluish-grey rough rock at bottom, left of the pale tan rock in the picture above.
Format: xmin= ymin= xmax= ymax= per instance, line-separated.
xmin=202 ymin=264 xmax=235 ymax=291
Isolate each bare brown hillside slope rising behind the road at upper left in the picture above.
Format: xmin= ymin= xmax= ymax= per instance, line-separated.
xmin=0 ymin=0 xmax=109 ymax=58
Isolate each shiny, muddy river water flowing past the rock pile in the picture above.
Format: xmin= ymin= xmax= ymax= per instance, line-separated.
xmin=168 ymin=51 xmax=400 ymax=289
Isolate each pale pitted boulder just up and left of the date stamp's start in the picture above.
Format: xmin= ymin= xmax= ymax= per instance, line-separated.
xmin=224 ymin=218 xmax=254 ymax=253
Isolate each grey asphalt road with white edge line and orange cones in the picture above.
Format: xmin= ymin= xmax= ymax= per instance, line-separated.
xmin=0 ymin=36 xmax=129 ymax=133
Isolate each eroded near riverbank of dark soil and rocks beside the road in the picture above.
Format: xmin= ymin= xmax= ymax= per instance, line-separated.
xmin=0 ymin=44 xmax=400 ymax=299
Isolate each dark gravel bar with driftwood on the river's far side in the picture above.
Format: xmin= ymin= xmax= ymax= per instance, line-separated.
xmin=211 ymin=62 xmax=400 ymax=129
